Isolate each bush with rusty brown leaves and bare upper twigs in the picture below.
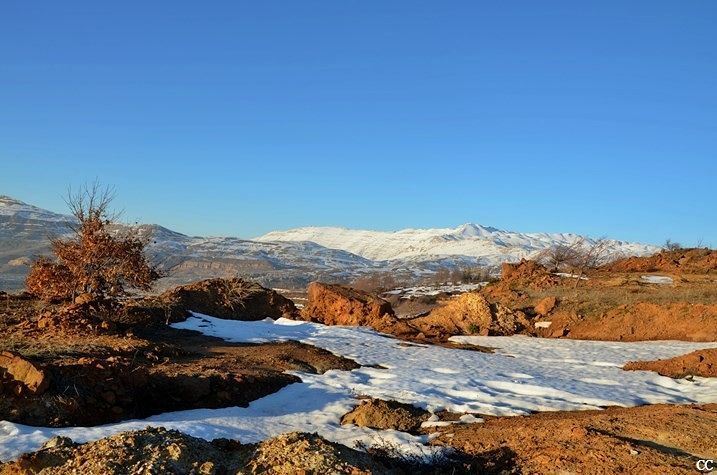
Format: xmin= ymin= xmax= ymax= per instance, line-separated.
xmin=26 ymin=184 xmax=159 ymax=300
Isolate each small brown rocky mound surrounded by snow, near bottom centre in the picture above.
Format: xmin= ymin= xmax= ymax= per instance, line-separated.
xmin=341 ymin=399 xmax=431 ymax=434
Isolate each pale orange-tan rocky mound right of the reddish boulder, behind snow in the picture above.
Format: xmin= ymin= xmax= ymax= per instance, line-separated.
xmin=411 ymin=292 xmax=528 ymax=336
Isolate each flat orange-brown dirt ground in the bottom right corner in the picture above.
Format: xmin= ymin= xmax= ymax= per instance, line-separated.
xmin=433 ymin=404 xmax=717 ymax=474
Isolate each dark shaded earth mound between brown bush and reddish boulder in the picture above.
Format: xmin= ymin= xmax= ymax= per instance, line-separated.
xmin=157 ymin=278 xmax=298 ymax=321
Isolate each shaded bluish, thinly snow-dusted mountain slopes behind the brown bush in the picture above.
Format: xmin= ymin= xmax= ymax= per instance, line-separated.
xmin=0 ymin=196 xmax=381 ymax=290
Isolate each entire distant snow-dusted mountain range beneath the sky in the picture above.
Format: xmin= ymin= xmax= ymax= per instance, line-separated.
xmin=0 ymin=196 xmax=658 ymax=290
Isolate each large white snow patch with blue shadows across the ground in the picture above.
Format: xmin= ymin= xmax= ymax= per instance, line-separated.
xmin=0 ymin=315 xmax=717 ymax=460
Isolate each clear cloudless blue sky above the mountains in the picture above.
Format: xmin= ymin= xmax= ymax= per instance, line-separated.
xmin=0 ymin=0 xmax=717 ymax=245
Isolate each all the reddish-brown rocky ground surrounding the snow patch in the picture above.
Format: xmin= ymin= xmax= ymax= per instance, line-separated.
xmin=0 ymin=251 xmax=717 ymax=474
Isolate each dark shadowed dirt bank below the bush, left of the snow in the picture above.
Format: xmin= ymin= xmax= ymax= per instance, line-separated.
xmin=0 ymin=299 xmax=358 ymax=427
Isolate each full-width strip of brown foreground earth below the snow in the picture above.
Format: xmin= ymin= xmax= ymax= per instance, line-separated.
xmin=0 ymin=402 xmax=717 ymax=475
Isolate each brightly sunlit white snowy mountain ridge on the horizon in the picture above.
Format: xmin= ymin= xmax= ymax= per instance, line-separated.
xmin=256 ymin=223 xmax=657 ymax=264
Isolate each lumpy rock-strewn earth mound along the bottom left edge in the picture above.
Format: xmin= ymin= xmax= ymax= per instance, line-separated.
xmin=0 ymin=427 xmax=391 ymax=475
